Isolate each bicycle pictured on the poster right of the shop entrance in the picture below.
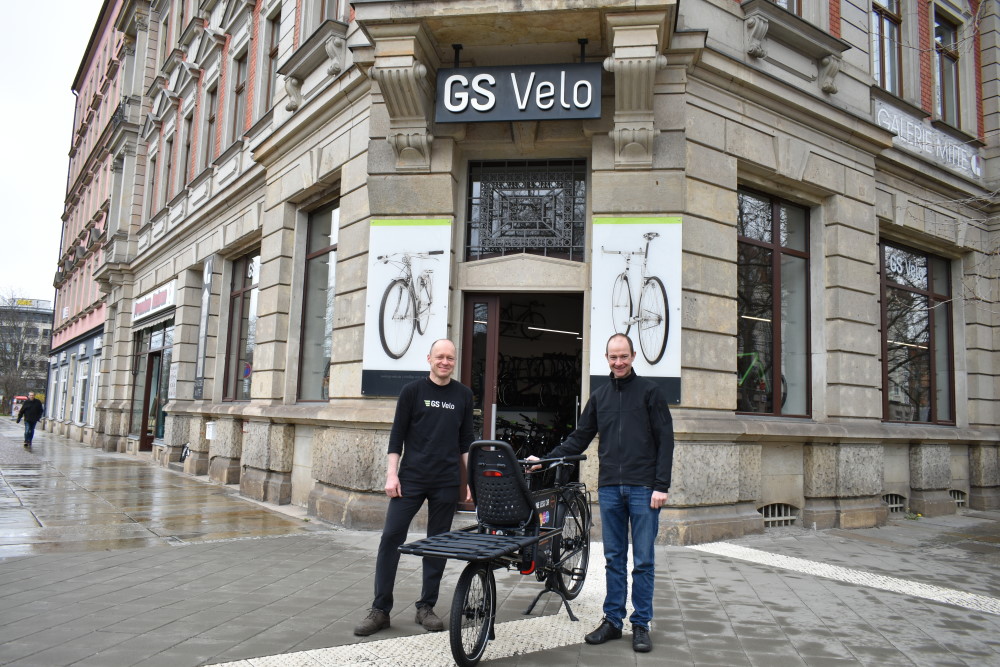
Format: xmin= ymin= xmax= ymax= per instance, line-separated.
xmin=601 ymin=232 xmax=670 ymax=364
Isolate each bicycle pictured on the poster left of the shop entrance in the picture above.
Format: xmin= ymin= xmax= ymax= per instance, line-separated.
xmin=377 ymin=250 xmax=444 ymax=359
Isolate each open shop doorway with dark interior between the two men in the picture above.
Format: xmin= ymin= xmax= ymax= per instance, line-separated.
xmin=462 ymin=293 xmax=583 ymax=457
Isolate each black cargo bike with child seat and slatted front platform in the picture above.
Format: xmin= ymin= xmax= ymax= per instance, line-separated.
xmin=399 ymin=440 xmax=591 ymax=667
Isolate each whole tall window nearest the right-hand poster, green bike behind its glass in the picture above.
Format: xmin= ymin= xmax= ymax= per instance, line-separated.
xmin=736 ymin=190 xmax=810 ymax=416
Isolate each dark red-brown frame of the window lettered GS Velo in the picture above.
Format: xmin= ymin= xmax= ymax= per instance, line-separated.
xmin=878 ymin=239 xmax=957 ymax=426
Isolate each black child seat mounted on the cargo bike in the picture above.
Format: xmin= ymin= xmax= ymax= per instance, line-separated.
xmin=469 ymin=440 xmax=538 ymax=531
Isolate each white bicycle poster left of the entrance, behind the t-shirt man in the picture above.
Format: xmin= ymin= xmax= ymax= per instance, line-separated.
xmin=361 ymin=218 xmax=451 ymax=396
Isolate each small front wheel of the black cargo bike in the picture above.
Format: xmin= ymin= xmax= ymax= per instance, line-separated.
xmin=448 ymin=561 xmax=496 ymax=667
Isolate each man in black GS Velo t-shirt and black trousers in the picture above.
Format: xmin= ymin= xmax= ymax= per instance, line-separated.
xmin=354 ymin=339 xmax=473 ymax=637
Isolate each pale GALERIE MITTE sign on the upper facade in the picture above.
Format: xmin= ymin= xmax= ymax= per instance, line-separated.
xmin=875 ymin=100 xmax=983 ymax=178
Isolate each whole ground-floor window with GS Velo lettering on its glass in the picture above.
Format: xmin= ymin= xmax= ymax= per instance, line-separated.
xmin=881 ymin=243 xmax=955 ymax=424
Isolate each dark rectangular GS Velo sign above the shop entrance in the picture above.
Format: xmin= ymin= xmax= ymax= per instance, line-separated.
xmin=434 ymin=63 xmax=601 ymax=123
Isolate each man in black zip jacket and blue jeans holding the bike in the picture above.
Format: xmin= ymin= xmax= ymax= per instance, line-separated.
xmin=546 ymin=334 xmax=674 ymax=653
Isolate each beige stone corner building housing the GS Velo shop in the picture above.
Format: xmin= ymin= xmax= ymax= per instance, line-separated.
xmin=80 ymin=0 xmax=1000 ymax=544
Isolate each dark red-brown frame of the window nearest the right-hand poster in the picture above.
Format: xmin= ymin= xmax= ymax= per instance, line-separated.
xmin=736 ymin=186 xmax=813 ymax=419
